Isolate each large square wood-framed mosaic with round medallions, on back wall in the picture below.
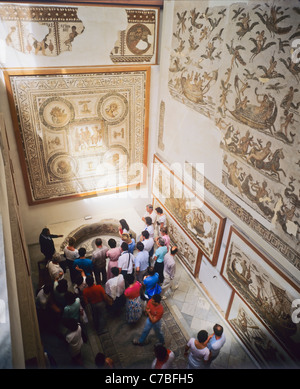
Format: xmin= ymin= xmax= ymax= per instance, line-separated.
xmin=4 ymin=66 xmax=150 ymax=205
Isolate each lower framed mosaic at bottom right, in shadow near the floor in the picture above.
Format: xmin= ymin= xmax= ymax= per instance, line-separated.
xmin=226 ymin=294 xmax=297 ymax=369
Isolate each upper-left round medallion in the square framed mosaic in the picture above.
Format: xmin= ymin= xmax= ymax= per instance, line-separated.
xmin=40 ymin=97 xmax=74 ymax=129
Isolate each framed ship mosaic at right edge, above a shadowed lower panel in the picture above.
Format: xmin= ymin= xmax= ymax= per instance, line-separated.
xmin=221 ymin=227 xmax=300 ymax=361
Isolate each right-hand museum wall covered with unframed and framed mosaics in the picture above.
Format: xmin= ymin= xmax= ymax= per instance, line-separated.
xmin=152 ymin=1 xmax=300 ymax=366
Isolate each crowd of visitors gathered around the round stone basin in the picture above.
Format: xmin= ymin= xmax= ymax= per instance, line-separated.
xmin=36 ymin=204 xmax=225 ymax=369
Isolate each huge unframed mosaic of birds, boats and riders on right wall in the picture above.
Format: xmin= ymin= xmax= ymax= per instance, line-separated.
xmin=169 ymin=1 xmax=300 ymax=272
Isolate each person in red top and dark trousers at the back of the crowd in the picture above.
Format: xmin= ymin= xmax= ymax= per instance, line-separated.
xmin=82 ymin=276 xmax=108 ymax=335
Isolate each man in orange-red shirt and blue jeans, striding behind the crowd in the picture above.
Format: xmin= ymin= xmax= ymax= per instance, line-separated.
xmin=133 ymin=294 xmax=165 ymax=346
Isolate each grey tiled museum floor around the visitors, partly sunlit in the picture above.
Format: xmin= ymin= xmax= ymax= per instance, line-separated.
xmin=29 ymin=241 xmax=257 ymax=369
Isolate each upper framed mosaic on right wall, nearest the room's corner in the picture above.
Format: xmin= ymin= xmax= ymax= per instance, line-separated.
xmin=152 ymin=155 xmax=225 ymax=266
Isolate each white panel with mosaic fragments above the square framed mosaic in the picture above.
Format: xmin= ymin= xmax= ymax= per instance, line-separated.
xmin=0 ymin=3 xmax=160 ymax=64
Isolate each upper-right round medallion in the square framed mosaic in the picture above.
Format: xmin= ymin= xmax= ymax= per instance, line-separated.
xmin=98 ymin=93 xmax=128 ymax=124
